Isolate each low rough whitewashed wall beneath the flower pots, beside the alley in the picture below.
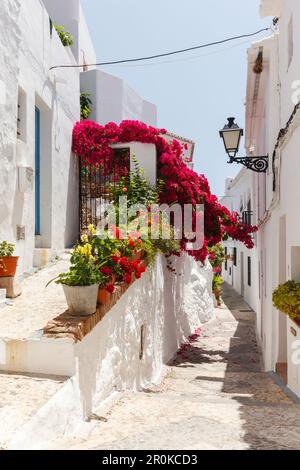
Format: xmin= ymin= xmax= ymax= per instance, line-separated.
xmin=6 ymin=254 xmax=214 ymax=449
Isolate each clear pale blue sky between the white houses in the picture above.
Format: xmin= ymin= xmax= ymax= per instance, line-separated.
xmin=81 ymin=0 xmax=271 ymax=197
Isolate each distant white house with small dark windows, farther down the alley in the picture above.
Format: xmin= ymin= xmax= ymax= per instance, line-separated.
xmin=221 ymin=168 xmax=258 ymax=311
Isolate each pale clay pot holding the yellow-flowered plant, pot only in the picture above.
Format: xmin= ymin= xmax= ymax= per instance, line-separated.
xmin=63 ymin=284 xmax=99 ymax=316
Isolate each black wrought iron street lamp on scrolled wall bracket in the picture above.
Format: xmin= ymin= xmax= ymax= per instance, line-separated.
xmin=220 ymin=117 xmax=269 ymax=173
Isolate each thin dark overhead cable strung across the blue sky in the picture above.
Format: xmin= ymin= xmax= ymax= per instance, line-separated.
xmin=50 ymin=28 xmax=271 ymax=70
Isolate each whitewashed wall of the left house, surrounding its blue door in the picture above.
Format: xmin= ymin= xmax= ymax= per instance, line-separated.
xmin=0 ymin=0 xmax=101 ymax=273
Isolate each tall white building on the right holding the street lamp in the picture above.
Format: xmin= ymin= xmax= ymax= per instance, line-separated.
xmin=229 ymin=0 xmax=300 ymax=396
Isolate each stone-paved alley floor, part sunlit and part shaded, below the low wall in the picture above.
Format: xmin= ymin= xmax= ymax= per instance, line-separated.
xmin=53 ymin=285 xmax=300 ymax=450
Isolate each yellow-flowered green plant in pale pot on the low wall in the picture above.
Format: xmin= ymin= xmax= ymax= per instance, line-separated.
xmin=50 ymin=243 xmax=105 ymax=316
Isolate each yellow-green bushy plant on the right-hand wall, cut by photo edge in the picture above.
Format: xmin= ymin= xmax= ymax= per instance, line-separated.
xmin=273 ymin=281 xmax=300 ymax=320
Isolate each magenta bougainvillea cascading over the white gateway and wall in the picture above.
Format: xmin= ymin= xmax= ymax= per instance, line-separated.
xmin=73 ymin=121 xmax=257 ymax=261
